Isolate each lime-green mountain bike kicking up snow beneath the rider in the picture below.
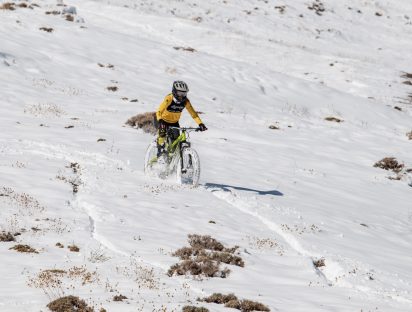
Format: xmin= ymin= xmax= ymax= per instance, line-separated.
xmin=144 ymin=127 xmax=200 ymax=186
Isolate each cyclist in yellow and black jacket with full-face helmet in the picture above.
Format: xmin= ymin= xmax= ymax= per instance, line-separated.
xmin=156 ymin=81 xmax=207 ymax=157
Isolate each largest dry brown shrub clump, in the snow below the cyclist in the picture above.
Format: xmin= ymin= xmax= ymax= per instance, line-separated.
xmin=168 ymin=234 xmax=245 ymax=278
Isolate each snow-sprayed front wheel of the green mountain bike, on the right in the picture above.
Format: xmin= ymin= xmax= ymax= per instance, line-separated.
xmin=176 ymin=147 xmax=200 ymax=186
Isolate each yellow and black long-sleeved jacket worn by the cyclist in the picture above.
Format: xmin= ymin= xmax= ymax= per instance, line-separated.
xmin=156 ymin=93 xmax=202 ymax=125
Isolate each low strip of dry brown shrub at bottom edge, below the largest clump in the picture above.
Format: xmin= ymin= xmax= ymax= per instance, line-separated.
xmin=198 ymin=293 xmax=270 ymax=312
